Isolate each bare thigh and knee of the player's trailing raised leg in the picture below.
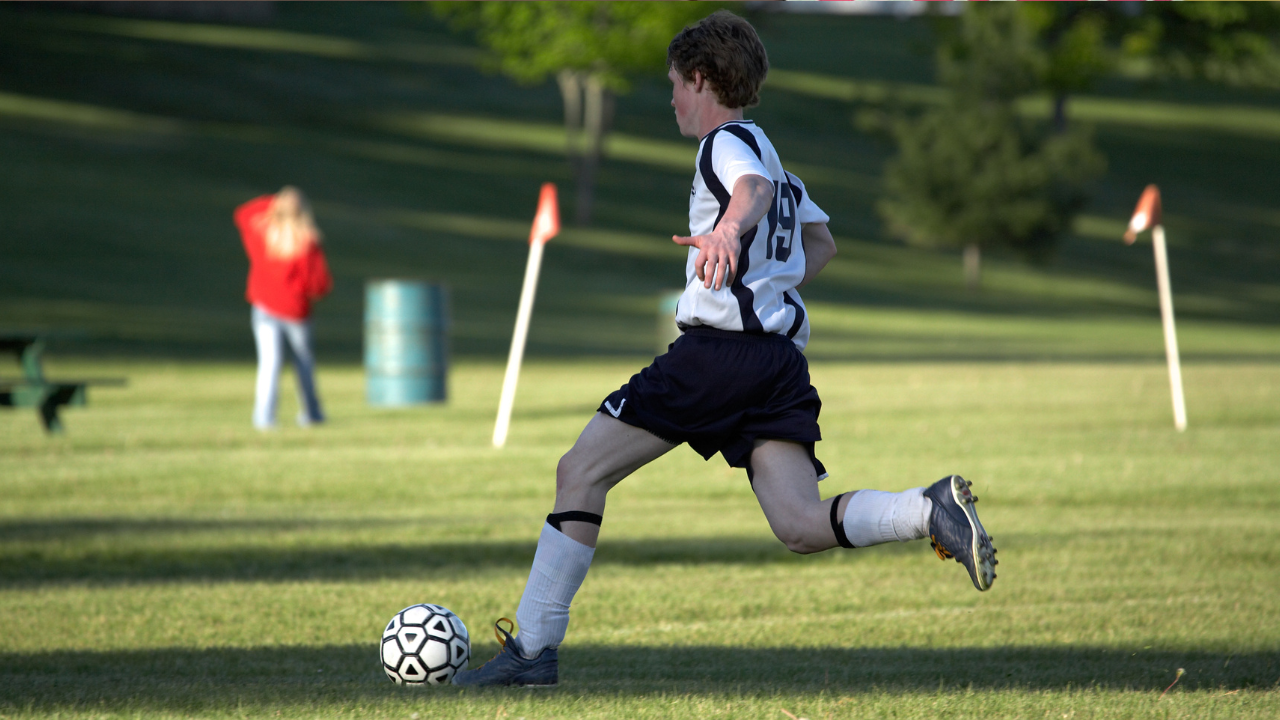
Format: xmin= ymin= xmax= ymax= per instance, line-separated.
xmin=751 ymin=439 xmax=822 ymax=530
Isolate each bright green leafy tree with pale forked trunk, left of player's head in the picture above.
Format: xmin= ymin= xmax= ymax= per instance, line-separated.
xmin=430 ymin=3 xmax=718 ymax=224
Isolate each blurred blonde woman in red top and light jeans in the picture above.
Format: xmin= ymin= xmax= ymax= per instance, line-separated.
xmin=236 ymin=186 xmax=333 ymax=430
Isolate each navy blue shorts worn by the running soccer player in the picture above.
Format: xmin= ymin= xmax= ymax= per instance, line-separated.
xmin=599 ymin=327 xmax=827 ymax=479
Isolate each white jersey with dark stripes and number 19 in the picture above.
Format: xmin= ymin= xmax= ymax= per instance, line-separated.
xmin=676 ymin=120 xmax=831 ymax=350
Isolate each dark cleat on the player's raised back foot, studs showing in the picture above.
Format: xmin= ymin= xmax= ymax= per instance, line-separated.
xmin=924 ymin=475 xmax=998 ymax=591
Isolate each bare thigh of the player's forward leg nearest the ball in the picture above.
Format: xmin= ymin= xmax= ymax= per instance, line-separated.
xmin=556 ymin=413 xmax=676 ymax=493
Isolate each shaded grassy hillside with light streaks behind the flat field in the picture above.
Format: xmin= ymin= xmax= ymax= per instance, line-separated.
xmin=0 ymin=4 xmax=1280 ymax=360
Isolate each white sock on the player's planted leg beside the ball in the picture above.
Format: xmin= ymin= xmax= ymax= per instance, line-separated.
xmin=516 ymin=524 xmax=595 ymax=660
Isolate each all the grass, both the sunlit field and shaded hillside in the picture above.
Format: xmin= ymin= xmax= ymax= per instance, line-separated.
xmin=0 ymin=3 xmax=1280 ymax=720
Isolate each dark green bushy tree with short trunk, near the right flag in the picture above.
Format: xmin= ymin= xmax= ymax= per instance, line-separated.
xmin=877 ymin=4 xmax=1105 ymax=288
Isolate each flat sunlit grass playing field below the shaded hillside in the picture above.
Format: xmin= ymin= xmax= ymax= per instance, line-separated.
xmin=0 ymin=361 xmax=1280 ymax=720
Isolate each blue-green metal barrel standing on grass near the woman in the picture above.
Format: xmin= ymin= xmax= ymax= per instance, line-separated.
xmin=365 ymin=279 xmax=448 ymax=407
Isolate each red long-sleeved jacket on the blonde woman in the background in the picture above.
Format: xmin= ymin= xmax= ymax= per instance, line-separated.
xmin=236 ymin=195 xmax=333 ymax=320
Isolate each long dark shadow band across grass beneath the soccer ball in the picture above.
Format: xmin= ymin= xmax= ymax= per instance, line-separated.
xmin=0 ymin=642 xmax=1280 ymax=712
